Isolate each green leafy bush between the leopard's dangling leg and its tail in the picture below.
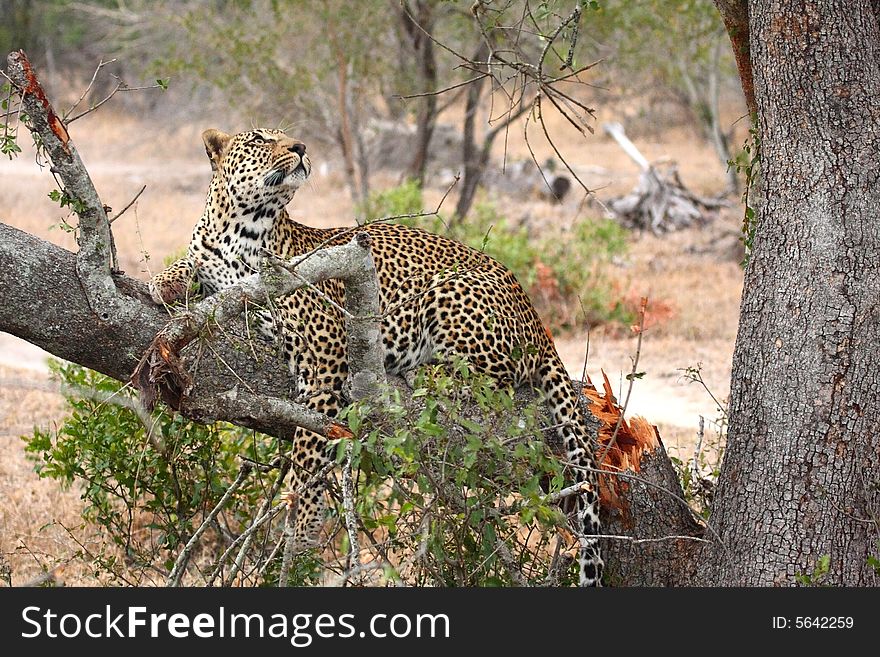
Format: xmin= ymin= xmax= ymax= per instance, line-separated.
xmin=337 ymin=362 xmax=576 ymax=586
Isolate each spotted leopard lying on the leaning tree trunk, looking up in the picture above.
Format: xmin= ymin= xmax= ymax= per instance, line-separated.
xmin=149 ymin=128 xmax=604 ymax=586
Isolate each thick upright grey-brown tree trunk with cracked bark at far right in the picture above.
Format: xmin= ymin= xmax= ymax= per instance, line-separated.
xmin=697 ymin=0 xmax=880 ymax=585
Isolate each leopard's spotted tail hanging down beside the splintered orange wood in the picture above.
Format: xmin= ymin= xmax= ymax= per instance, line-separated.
xmin=540 ymin=349 xmax=604 ymax=586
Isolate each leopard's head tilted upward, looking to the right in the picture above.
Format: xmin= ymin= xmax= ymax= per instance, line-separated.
xmin=202 ymin=129 xmax=312 ymax=206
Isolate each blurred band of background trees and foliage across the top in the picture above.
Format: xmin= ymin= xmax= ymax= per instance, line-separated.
xmin=0 ymin=0 xmax=744 ymax=210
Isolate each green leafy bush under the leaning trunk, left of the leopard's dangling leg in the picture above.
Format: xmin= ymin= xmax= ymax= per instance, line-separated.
xmin=23 ymin=362 xmax=310 ymax=583
